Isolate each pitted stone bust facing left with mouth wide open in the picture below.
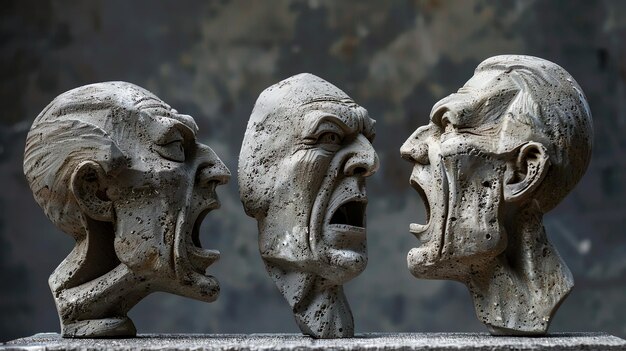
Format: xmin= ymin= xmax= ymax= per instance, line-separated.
xmin=401 ymin=56 xmax=592 ymax=335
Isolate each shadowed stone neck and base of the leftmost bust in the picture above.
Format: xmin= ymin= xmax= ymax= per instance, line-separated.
xmin=49 ymin=218 xmax=149 ymax=337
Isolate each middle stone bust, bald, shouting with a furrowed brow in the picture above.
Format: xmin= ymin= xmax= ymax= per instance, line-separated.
xmin=239 ymin=74 xmax=378 ymax=338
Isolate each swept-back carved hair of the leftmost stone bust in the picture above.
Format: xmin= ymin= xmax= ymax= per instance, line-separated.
xmin=24 ymin=82 xmax=160 ymax=240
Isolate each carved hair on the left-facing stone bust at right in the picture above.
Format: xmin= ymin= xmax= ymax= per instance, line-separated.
xmin=476 ymin=55 xmax=593 ymax=213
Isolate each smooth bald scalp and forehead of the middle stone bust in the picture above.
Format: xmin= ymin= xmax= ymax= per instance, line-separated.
xmin=239 ymin=73 xmax=374 ymax=218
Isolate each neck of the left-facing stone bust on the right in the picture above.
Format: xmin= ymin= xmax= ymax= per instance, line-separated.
xmin=466 ymin=209 xmax=574 ymax=335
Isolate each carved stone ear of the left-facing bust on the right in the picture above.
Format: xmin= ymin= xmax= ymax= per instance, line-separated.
xmin=504 ymin=141 xmax=550 ymax=202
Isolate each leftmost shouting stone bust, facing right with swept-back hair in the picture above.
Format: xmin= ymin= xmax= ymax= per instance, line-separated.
xmin=24 ymin=82 xmax=230 ymax=338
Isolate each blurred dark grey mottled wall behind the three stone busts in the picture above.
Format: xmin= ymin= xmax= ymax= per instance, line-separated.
xmin=0 ymin=0 xmax=626 ymax=340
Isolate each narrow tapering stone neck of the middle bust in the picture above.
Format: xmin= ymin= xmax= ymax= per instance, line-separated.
xmin=265 ymin=261 xmax=354 ymax=339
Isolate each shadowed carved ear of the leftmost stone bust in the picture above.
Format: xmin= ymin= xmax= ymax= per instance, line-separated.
xmin=70 ymin=161 xmax=113 ymax=222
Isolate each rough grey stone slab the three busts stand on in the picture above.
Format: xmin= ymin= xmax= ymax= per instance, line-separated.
xmin=0 ymin=333 xmax=626 ymax=351
